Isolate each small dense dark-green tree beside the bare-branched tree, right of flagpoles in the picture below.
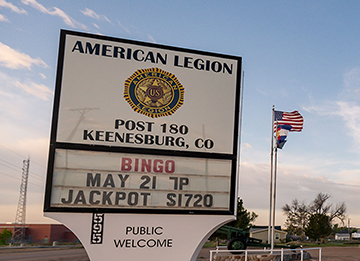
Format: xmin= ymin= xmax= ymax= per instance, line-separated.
xmin=305 ymin=213 xmax=332 ymax=242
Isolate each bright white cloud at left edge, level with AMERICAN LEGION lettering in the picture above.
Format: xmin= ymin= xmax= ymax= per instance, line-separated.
xmin=0 ymin=42 xmax=48 ymax=70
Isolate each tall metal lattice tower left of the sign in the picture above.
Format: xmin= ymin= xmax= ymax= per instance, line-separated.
xmin=11 ymin=158 xmax=30 ymax=242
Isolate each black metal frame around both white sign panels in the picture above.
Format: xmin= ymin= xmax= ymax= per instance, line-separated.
xmin=44 ymin=30 xmax=241 ymax=215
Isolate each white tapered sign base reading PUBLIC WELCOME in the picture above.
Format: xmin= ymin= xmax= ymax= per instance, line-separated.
xmin=45 ymin=213 xmax=234 ymax=261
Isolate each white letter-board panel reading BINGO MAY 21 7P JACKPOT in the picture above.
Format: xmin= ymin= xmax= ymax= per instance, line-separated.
xmin=51 ymin=149 xmax=231 ymax=212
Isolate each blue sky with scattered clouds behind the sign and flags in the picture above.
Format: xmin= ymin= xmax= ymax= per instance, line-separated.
xmin=0 ymin=0 xmax=360 ymax=227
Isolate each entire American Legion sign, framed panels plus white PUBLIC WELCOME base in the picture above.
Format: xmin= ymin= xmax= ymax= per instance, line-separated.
xmin=44 ymin=30 xmax=241 ymax=261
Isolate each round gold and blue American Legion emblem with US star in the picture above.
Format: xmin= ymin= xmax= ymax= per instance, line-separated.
xmin=124 ymin=68 xmax=184 ymax=118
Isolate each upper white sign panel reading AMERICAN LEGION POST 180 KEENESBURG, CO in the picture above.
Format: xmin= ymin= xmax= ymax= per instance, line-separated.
xmin=56 ymin=34 xmax=240 ymax=154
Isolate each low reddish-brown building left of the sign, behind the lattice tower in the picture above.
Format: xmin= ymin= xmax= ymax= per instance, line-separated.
xmin=0 ymin=221 xmax=79 ymax=244
